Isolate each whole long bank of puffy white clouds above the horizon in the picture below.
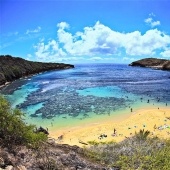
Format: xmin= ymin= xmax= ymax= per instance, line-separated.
xmin=35 ymin=21 xmax=170 ymax=60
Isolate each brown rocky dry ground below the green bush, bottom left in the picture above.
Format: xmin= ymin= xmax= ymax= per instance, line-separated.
xmin=0 ymin=143 xmax=108 ymax=170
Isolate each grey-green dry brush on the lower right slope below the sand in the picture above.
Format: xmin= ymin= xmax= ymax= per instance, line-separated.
xmin=84 ymin=130 xmax=170 ymax=170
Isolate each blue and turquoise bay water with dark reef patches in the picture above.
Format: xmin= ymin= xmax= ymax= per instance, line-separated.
xmin=1 ymin=64 xmax=170 ymax=127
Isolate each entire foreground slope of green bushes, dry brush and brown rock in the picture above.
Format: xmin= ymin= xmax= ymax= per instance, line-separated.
xmin=0 ymin=96 xmax=170 ymax=170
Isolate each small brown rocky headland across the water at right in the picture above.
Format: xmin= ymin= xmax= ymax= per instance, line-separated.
xmin=129 ymin=58 xmax=170 ymax=70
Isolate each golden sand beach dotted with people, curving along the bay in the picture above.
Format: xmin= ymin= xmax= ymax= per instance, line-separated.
xmin=50 ymin=107 xmax=170 ymax=147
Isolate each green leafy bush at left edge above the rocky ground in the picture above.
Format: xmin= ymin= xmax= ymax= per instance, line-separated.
xmin=0 ymin=96 xmax=47 ymax=148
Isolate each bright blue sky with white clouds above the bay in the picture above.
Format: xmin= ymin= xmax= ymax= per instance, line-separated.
xmin=0 ymin=0 xmax=170 ymax=63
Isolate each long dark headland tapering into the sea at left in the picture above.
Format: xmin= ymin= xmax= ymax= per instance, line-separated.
xmin=0 ymin=55 xmax=74 ymax=86
